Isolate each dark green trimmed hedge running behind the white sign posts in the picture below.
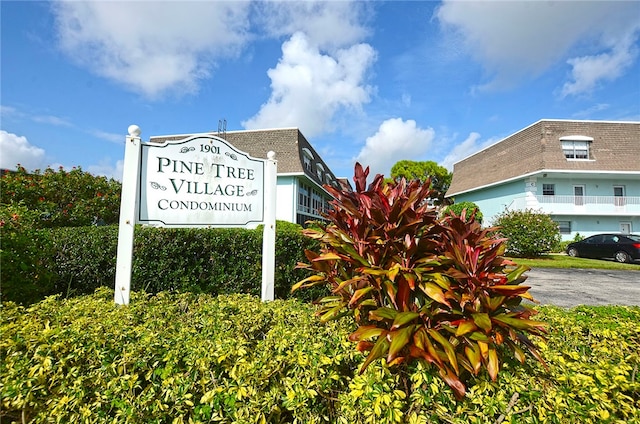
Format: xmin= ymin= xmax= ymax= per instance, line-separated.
xmin=1 ymin=226 xmax=322 ymax=304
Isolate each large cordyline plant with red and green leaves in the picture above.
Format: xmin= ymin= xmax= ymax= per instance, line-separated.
xmin=292 ymin=164 xmax=546 ymax=399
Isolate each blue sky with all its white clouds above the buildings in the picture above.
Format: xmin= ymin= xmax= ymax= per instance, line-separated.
xmin=0 ymin=0 xmax=640 ymax=179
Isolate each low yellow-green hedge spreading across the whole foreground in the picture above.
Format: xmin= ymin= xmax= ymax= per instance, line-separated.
xmin=0 ymin=288 xmax=640 ymax=424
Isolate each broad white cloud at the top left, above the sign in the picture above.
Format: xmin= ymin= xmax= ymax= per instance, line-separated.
xmin=52 ymin=1 xmax=250 ymax=97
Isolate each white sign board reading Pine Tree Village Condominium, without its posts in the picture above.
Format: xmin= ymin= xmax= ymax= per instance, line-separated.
xmin=138 ymin=135 xmax=265 ymax=227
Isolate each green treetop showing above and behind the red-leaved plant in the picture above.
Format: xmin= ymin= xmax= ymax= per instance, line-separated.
xmin=391 ymin=160 xmax=452 ymax=203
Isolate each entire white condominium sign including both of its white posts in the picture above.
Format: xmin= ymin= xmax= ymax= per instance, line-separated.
xmin=115 ymin=125 xmax=277 ymax=305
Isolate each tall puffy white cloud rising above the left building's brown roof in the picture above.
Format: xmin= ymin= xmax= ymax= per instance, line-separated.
xmin=242 ymin=32 xmax=375 ymax=137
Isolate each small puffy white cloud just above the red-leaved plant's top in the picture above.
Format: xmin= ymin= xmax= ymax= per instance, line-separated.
xmin=355 ymin=118 xmax=435 ymax=177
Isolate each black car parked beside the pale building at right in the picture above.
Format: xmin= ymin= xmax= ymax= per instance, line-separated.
xmin=567 ymin=234 xmax=640 ymax=262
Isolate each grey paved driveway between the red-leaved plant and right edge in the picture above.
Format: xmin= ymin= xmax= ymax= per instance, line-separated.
xmin=524 ymin=265 xmax=640 ymax=307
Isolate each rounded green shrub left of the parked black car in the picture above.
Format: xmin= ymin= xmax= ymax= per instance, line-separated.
xmin=494 ymin=209 xmax=560 ymax=257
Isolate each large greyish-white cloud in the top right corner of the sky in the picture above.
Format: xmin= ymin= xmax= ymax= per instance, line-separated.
xmin=436 ymin=0 xmax=640 ymax=95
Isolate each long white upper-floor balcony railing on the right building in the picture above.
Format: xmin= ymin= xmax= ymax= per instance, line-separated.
xmin=508 ymin=195 xmax=640 ymax=216
